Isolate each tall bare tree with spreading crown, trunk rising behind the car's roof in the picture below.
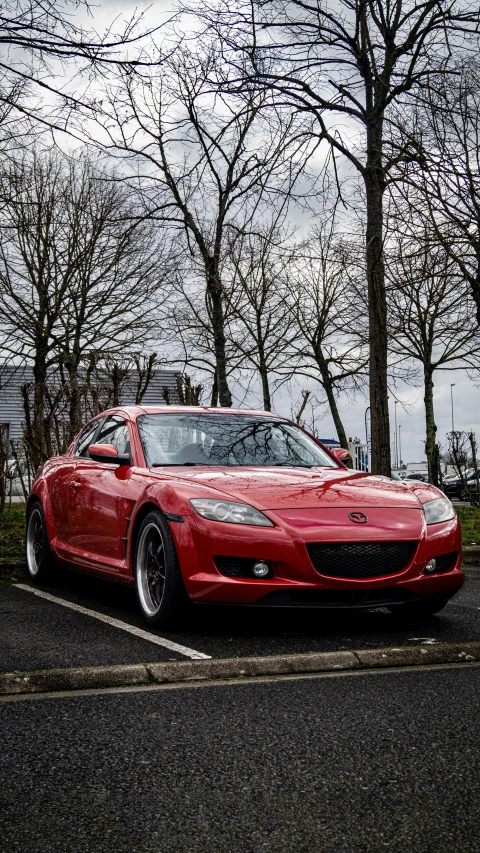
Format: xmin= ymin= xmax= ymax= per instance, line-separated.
xmin=99 ymin=41 xmax=312 ymax=406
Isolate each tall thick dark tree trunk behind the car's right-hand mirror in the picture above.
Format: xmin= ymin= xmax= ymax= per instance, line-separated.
xmin=364 ymin=119 xmax=391 ymax=477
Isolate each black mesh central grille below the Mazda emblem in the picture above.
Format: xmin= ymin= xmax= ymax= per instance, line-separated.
xmin=307 ymin=542 xmax=418 ymax=580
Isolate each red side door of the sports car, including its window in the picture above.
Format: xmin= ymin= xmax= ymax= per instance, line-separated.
xmin=68 ymin=415 xmax=130 ymax=571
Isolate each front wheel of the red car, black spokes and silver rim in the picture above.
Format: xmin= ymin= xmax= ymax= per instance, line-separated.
xmin=134 ymin=510 xmax=189 ymax=627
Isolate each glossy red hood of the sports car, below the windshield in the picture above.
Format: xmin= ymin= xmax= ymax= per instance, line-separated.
xmin=156 ymin=467 xmax=426 ymax=510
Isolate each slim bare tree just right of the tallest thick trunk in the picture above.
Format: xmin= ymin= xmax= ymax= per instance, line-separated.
xmin=388 ymin=233 xmax=480 ymax=485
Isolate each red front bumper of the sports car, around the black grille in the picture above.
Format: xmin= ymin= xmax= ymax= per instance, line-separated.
xmin=171 ymin=506 xmax=464 ymax=609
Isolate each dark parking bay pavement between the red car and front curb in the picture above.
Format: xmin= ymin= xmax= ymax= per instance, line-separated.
xmin=0 ymin=569 xmax=480 ymax=671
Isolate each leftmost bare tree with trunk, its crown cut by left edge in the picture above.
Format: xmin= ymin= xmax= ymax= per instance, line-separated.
xmin=0 ymin=150 xmax=73 ymax=464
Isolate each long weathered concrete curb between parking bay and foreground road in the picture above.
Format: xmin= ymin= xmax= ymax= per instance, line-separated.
xmin=0 ymin=642 xmax=480 ymax=696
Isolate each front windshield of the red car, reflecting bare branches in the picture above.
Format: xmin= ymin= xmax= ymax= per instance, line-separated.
xmin=137 ymin=412 xmax=338 ymax=468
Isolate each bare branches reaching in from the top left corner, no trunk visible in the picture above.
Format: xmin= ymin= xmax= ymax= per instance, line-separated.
xmin=0 ymin=0 xmax=153 ymax=148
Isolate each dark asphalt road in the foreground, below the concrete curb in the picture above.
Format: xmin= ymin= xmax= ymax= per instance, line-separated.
xmin=0 ymin=667 xmax=480 ymax=853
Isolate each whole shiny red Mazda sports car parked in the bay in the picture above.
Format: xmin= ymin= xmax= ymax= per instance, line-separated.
xmin=26 ymin=406 xmax=464 ymax=625
